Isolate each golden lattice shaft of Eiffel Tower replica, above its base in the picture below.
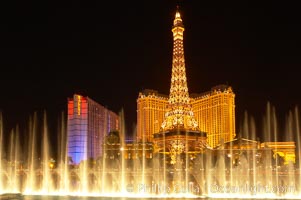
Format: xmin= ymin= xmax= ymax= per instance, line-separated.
xmin=161 ymin=6 xmax=198 ymax=131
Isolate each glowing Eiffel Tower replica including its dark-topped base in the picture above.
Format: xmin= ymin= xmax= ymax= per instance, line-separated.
xmin=153 ymin=9 xmax=206 ymax=165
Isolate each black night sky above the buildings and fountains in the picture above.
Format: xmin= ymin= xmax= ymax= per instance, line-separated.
xmin=0 ymin=0 xmax=301 ymax=142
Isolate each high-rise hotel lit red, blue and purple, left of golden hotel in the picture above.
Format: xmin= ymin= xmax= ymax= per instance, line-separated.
xmin=67 ymin=94 xmax=119 ymax=164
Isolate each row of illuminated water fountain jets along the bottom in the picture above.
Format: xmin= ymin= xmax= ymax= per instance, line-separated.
xmin=0 ymin=104 xmax=301 ymax=198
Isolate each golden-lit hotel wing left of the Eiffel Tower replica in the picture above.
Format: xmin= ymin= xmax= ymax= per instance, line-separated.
xmin=137 ymin=90 xmax=168 ymax=142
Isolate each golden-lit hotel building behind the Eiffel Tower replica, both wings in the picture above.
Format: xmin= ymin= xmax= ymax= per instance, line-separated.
xmin=137 ymin=85 xmax=236 ymax=148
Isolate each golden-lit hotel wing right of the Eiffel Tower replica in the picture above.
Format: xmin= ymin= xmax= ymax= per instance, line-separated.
xmin=191 ymin=85 xmax=236 ymax=148
